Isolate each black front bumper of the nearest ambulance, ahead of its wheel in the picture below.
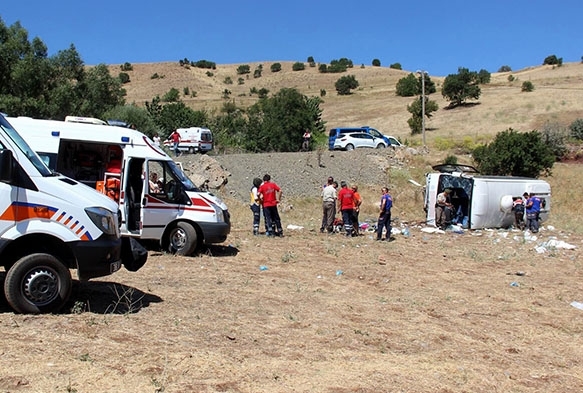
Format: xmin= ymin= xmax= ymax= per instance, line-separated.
xmin=71 ymin=235 xmax=122 ymax=281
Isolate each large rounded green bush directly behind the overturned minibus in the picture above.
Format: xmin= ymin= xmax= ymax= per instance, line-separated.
xmin=473 ymin=128 xmax=555 ymax=178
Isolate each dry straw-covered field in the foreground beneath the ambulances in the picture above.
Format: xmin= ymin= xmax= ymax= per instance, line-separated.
xmin=0 ymin=213 xmax=583 ymax=393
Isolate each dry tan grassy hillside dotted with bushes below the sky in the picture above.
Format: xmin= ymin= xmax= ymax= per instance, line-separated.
xmin=110 ymin=62 xmax=583 ymax=146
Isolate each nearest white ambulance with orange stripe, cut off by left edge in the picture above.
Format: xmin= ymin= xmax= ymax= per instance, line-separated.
xmin=0 ymin=115 xmax=145 ymax=314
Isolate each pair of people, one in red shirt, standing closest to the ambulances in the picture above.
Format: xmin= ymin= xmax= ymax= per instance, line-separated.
xmin=249 ymin=174 xmax=283 ymax=237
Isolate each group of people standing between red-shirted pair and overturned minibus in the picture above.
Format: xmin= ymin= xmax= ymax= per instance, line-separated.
xmin=320 ymin=177 xmax=394 ymax=240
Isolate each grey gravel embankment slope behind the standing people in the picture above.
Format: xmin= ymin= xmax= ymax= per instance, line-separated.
xmin=177 ymin=149 xmax=404 ymax=201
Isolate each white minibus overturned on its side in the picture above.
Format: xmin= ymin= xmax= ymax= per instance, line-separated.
xmin=424 ymin=165 xmax=551 ymax=229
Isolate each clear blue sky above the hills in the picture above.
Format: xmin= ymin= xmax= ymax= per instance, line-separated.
xmin=0 ymin=0 xmax=583 ymax=76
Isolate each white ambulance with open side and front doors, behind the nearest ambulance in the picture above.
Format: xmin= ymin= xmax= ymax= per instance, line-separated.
xmin=9 ymin=117 xmax=231 ymax=255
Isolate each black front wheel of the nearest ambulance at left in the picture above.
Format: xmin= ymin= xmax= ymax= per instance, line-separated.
xmin=4 ymin=254 xmax=72 ymax=314
